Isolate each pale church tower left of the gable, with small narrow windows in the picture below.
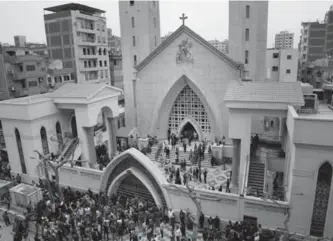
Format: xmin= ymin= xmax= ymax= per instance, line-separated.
xmin=119 ymin=1 xmax=161 ymax=128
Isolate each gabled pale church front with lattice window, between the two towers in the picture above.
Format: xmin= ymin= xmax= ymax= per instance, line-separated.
xmin=133 ymin=25 xmax=243 ymax=140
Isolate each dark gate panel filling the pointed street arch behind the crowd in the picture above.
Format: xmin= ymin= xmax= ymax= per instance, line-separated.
xmin=117 ymin=174 xmax=155 ymax=203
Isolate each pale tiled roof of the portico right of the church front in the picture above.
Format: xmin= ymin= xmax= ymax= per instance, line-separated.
xmin=224 ymin=82 xmax=304 ymax=106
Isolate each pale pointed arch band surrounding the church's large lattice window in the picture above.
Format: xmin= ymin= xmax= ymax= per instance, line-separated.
xmin=150 ymin=75 xmax=221 ymax=139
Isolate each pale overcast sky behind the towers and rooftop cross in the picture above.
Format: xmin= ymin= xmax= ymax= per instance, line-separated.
xmin=0 ymin=0 xmax=333 ymax=48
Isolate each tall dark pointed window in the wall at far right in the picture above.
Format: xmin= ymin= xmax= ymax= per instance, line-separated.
xmin=310 ymin=162 xmax=332 ymax=237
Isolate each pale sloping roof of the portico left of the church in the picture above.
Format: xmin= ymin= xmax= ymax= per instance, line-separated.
xmin=50 ymin=83 xmax=105 ymax=98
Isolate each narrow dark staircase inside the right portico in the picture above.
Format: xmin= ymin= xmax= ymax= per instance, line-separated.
xmin=247 ymin=161 xmax=265 ymax=196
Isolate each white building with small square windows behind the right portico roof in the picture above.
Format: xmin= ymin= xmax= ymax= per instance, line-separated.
xmin=266 ymin=48 xmax=298 ymax=82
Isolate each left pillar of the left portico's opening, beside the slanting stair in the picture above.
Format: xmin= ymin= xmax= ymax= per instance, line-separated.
xmin=79 ymin=127 xmax=97 ymax=167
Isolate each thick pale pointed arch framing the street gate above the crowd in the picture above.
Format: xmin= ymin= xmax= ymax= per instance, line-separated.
xmin=100 ymin=148 xmax=171 ymax=207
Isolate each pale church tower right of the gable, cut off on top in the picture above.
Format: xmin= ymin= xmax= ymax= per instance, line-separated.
xmin=229 ymin=0 xmax=268 ymax=81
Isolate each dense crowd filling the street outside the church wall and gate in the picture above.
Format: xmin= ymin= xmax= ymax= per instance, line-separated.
xmin=9 ymin=177 xmax=261 ymax=241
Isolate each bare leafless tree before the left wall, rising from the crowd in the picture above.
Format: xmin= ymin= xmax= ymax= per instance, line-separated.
xmin=34 ymin=139 xmax=78 ymax=201
